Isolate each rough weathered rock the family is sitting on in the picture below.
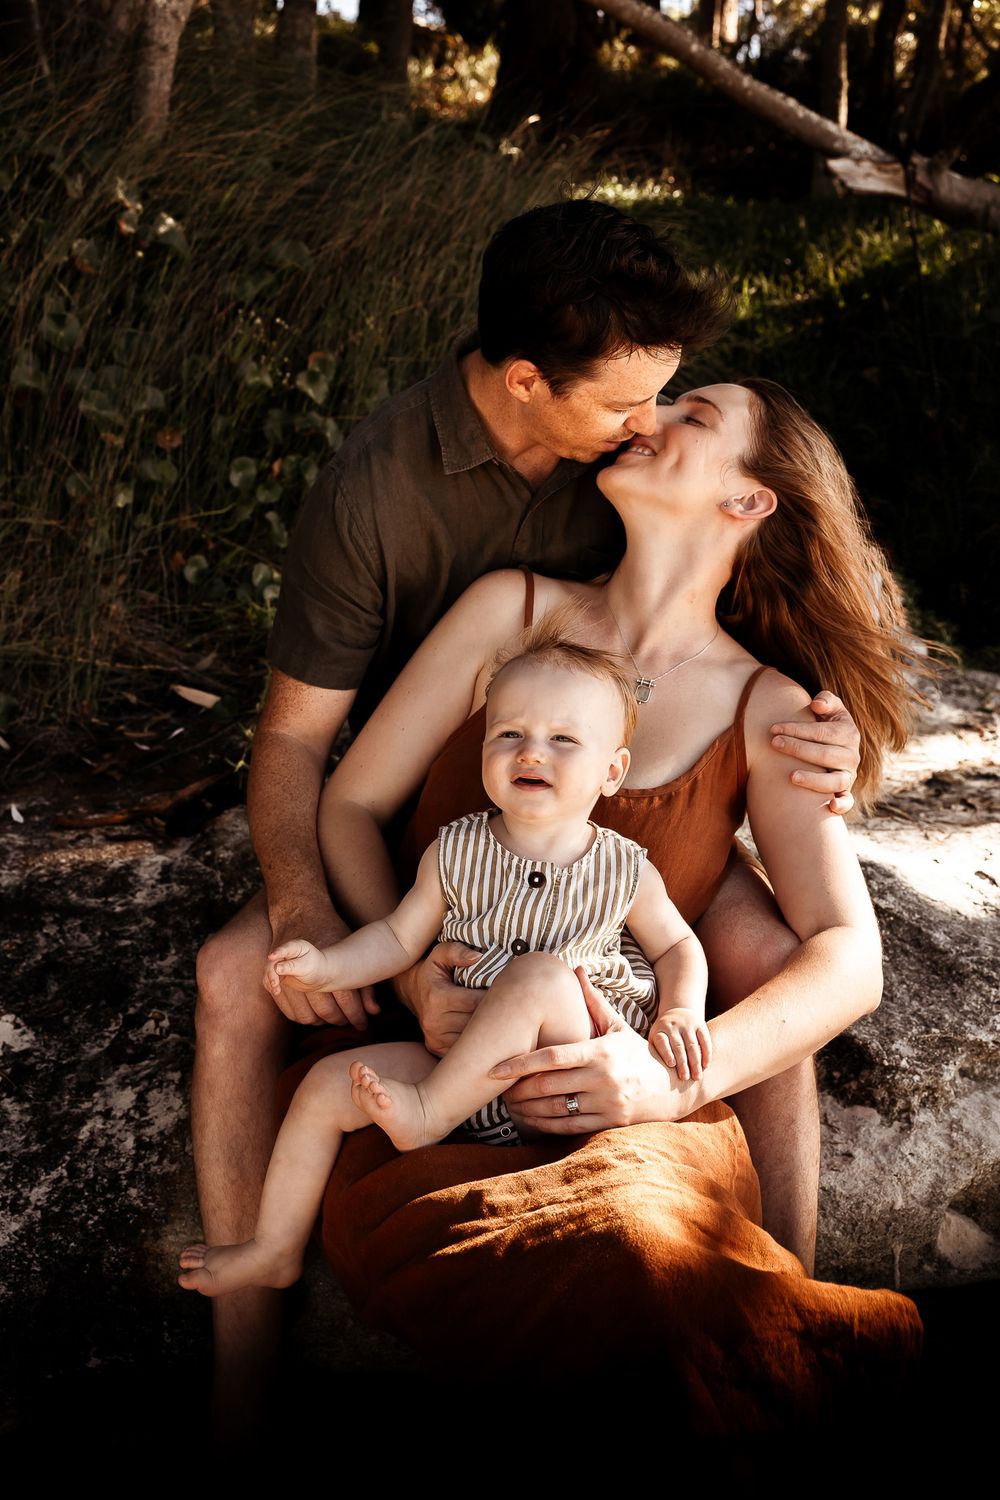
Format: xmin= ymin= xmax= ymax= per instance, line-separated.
xmin=0 ymin=671 xmax=1000 ymax=1421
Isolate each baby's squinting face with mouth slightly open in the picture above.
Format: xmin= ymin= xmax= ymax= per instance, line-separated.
xmin=483 ymin=662 xmax=628 ymax=821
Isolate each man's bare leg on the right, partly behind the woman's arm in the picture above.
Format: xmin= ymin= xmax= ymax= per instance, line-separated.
xmin=697 ymin=861 xmax=820 ymax=1275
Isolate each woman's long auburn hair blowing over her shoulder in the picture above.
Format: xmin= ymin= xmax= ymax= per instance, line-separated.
xmin=720 ymin=380 xmax=934 ymax=809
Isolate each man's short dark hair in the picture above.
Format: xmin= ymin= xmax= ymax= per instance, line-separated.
xmin=478 ymin=198 xmax=730 ymax=395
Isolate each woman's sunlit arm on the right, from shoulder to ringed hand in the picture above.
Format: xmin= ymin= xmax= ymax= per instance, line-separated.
xmin=493 ymin=674 xmax=882 ymax=1133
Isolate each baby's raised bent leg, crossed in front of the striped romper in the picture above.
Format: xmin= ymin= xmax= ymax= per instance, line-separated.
xmin=351 ymin=953 xmax=592 ymax=1151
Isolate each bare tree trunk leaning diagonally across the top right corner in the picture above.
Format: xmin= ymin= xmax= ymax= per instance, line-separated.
xmin=585 ymin=0 xmax=1000 ymax=234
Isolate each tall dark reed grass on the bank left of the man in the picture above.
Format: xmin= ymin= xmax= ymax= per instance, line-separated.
xmin=0 ymin=70 xmax=593 ymax=714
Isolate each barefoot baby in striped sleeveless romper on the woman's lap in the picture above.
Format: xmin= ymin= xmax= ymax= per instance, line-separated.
xmin=180 ymin=621 xmax=711 ymax=1296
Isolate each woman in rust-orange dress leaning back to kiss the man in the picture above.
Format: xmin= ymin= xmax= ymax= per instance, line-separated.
xmin=280 ymin=381 xmax=915 ymax=1425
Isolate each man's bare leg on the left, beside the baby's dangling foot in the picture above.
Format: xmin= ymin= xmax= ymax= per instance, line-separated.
xmin=190 ymin=891 xmax=291 ymax=1443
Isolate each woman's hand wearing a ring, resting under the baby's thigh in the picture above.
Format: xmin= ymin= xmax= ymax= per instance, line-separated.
xmin=490 ymin=969 xmax=702 ymax=1136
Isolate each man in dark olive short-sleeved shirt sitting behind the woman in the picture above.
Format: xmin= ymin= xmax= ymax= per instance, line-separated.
xmin=192 ymin=201 xmax=858 ymax=1422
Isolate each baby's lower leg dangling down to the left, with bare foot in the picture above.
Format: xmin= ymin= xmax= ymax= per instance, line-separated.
xmin=178 ymin=1041 xmax=435 ymax=1298
